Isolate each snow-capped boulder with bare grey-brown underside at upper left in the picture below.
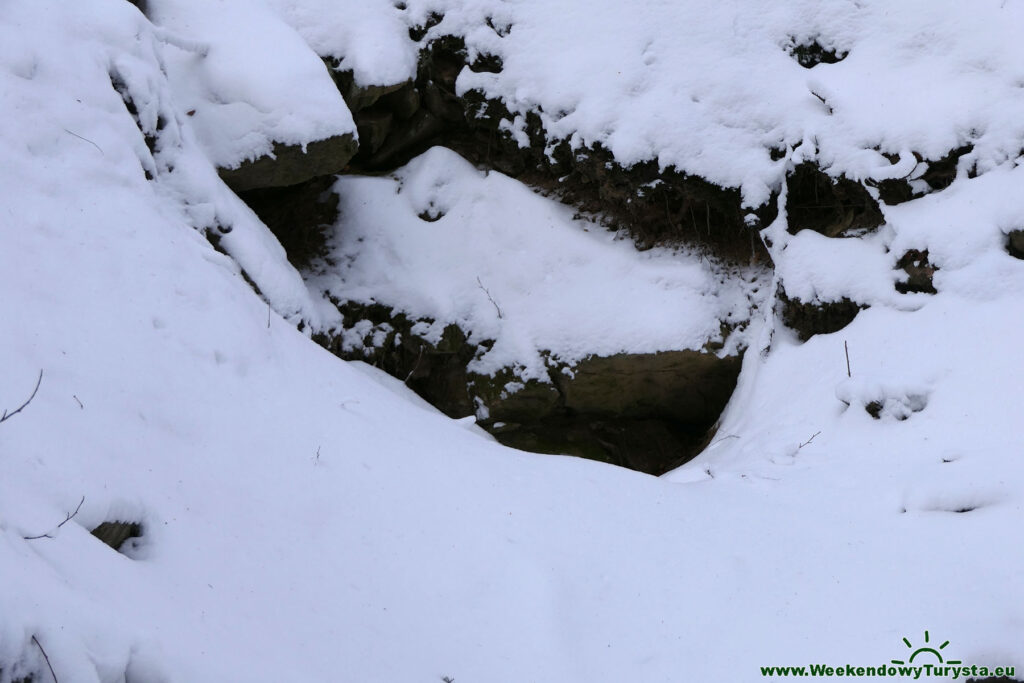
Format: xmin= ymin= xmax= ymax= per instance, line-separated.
xmin=145 ymin=0 xmax=357 ymax=191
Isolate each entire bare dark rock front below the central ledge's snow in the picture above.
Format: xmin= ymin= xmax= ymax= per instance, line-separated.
xmin=317 ymin=303 xmax=740 ymax=474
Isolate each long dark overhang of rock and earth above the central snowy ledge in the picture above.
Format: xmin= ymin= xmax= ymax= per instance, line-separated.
xmin=323 ymin=36 xmax=776 ymax=263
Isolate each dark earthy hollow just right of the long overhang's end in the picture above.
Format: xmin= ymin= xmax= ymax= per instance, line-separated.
xmin=785 ymin=162 xmax=885 ymax=238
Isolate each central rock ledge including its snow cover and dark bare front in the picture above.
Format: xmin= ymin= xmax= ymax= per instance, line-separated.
xmin=307 ymin=147 xmax=770 ymax=474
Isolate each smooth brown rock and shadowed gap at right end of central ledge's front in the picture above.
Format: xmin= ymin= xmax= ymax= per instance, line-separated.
xmin=480 ymin=351 xmax=740 ymax=474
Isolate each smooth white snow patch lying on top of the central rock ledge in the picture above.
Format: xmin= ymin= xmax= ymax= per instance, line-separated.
xmin=308 ymin=147 xmax=770 ymax=381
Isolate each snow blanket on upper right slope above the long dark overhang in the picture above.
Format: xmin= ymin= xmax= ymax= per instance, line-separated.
xmin=436 ymin=0 xmax=1024 ymax=206
